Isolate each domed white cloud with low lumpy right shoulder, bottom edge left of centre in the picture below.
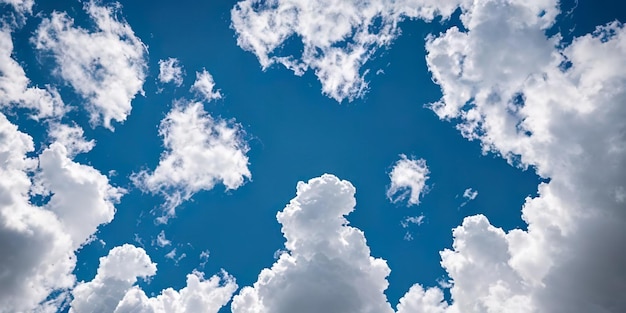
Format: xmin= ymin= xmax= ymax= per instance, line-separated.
xmin=70 ymin=244 xmax=237 ymax=313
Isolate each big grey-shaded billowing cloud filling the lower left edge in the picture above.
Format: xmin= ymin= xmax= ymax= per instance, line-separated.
xmin=0 ymin=114 xmax=123 ymax=312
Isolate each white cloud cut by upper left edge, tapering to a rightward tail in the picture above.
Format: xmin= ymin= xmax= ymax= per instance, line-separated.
xmin=0 ymin=27 xmax=66 ymax=119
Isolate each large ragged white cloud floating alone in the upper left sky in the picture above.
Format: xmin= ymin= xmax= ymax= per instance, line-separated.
xmin=33 ymin=1 xmax=147 ymax=129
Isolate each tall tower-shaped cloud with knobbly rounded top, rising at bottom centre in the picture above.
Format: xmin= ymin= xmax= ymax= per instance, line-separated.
xmin=231 ymin=174 xmax=393 ymax=313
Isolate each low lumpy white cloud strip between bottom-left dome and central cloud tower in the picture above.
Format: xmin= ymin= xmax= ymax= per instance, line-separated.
xmin=114 ymin=272 xmax=237 ymax=313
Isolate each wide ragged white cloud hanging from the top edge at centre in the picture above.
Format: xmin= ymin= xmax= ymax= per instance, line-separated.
xmin=231 ymin=0 xmax=462 ymax=102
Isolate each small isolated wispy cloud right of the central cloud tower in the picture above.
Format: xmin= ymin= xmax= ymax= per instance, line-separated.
xmin=387 ymin=154 xmax=429 ymax=206
